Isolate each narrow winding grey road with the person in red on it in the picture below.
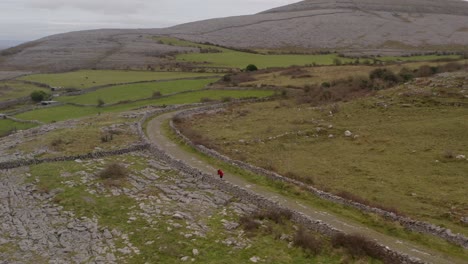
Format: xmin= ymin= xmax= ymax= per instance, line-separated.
xmin=146 ymin=112 xmax=466 ymax=264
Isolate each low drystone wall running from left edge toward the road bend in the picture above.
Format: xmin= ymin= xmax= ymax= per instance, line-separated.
xmin=0 ymin=144 xmax=149 ymax=170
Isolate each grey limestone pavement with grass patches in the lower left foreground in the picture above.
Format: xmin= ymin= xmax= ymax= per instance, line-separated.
xmin=0 ymin=143 xmax=255 ymax=263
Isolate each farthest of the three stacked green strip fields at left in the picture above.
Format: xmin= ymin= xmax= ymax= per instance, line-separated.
xmin=20 ymin=70 xmax=216 ymax=89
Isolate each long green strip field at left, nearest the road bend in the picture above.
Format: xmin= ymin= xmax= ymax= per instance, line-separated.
xmin=15 ymin=90 xmax=274 ymax=123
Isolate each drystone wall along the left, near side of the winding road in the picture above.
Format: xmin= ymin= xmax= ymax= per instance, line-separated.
xmin=138 ymin=104 xmax=424 ymax=264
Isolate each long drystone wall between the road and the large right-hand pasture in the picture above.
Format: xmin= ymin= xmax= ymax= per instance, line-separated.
xmin=170 ymin=105 xmax=468 ymax=248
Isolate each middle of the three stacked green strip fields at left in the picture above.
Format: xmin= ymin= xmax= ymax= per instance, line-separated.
xmin=57 ymin=79 xmax=217 ymax=105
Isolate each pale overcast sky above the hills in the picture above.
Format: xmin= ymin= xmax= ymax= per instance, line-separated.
xmin=0 ymin=0 xmax=299 ymax=40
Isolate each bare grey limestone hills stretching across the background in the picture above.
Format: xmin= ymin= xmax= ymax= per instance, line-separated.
xmin=0 ymin=0 xmax=468 ymax=70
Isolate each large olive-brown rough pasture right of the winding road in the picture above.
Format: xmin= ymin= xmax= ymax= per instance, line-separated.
xmin=178 ymin=73 xmax=468 ymax=234
